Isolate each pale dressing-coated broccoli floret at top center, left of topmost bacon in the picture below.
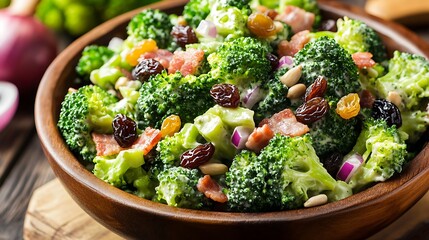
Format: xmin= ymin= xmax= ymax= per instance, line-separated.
xmin=206 ymin=0 xmax=252 ymax=41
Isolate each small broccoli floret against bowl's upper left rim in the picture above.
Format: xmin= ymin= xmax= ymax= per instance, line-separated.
xmin=76 ymin=45 xmax=114 ymax=79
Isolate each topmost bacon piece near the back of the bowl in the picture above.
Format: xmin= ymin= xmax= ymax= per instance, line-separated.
xmin=276 ymin=6 xmax=315 ymax=33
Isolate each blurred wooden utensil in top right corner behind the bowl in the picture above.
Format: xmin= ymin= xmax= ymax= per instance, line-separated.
xmin=365 ymin=0 xmax=429 ymax=24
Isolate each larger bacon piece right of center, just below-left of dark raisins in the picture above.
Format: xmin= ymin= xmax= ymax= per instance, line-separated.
xmin=263 ymin=108 xmax=310 ymax=137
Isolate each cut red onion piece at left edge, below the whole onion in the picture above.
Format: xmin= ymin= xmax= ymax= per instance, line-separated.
xmin=0 ymin=82 xmax=19 ymax=131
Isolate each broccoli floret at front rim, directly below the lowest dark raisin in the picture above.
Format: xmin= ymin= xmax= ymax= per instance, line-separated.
xmin=155 ymin=167 xmax=205 ymax=209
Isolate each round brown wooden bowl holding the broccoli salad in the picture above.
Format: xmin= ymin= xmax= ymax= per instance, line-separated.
xmin=35 ymin=0 xmax=429 ymax=239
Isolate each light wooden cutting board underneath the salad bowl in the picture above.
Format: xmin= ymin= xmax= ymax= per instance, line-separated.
xmin=24 ymin=179 xmax=429 ymax=240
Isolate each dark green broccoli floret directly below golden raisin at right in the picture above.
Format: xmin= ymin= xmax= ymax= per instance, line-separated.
xmin=309 ymin=101 xmax=360 ymax=157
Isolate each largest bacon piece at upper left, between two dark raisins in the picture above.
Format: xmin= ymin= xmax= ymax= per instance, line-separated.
xmin=168 ymin=48 xmax=204 ymax=76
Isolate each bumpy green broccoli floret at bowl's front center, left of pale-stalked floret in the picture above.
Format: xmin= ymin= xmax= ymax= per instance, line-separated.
xmin=225 ymin=150 xmax=272 ymax=212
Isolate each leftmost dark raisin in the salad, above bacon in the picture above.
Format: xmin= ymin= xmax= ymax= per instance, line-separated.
xmin=112 ymin=114 xmax=138 ymax=148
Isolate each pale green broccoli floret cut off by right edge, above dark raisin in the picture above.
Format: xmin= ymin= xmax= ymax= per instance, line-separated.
xmin=376 ymin=51 xmax=429 ymax=110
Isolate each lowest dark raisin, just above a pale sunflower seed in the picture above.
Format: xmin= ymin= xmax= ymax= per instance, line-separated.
xmin=180 ymin=143 xmax=215 ymax=168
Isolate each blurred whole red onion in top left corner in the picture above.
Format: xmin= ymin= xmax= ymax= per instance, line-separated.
xmin=0 ymin=0 xmax=57 ymax=94
